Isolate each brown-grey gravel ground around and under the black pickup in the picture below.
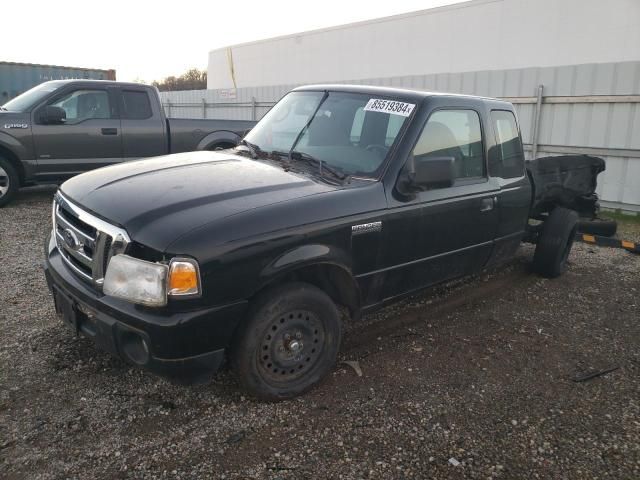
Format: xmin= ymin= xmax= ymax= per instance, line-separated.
xmin=0 ymin=189 xmax=640 ymax=479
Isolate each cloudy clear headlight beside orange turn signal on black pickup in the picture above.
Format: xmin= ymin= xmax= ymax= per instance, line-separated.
xmin=102 ymin=255 xmax=169 ymax=307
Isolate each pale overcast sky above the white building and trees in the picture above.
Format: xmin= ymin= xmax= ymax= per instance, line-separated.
xmin=0 ymin=0 xmax=461 ymax=82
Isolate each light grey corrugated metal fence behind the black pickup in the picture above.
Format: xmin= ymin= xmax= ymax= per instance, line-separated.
xmin=161 ymin=61 xmax=640 ymax=211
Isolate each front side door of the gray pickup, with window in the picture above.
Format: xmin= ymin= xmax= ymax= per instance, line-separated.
xmin=33 ymin=86 xmax=122 ymax=181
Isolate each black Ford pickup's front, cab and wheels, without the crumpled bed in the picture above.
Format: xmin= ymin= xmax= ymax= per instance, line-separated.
xmin=45 ymin=85 xmax=577 ymax=400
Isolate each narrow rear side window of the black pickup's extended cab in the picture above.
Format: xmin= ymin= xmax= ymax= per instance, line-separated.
xmin=491 ymin=110 xmax=524 ymax=178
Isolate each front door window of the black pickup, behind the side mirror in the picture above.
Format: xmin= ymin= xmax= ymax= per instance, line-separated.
xmin=413 ymin=110 xmax=485 ymax=179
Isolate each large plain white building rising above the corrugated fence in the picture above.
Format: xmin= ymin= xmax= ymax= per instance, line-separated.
xmin=207 ymin=0 xmax=640 ymax=89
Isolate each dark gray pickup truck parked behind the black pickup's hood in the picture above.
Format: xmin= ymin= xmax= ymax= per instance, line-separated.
xmin=0 ymin=80 xmax=255 ymax=207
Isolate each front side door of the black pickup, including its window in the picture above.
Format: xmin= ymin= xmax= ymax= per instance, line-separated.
xmin=381 ymin=107 xmax=499 ymax=299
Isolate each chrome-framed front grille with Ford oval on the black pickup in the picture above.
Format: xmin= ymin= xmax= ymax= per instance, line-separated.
xmin=53 ymin=192 xmax=130 ymax=288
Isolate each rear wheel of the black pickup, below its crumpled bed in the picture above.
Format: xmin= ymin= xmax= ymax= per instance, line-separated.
xmin=533 ymin=207 xmax=578 ymax=278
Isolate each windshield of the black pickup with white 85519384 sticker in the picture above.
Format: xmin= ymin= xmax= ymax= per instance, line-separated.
xmin=245 ymin=91 xmax=415 ymax=177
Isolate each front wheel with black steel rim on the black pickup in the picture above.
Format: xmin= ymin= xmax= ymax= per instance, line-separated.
xmin=230 ymin=283 xmax=342 ymax=400
